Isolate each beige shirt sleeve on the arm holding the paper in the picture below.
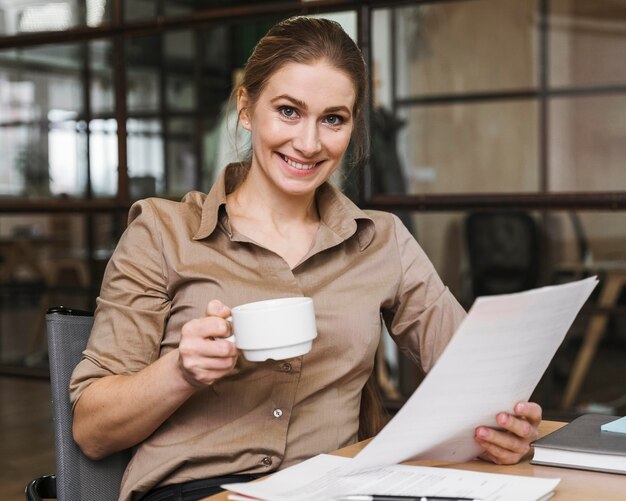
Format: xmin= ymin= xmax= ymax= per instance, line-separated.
xmin=386 ymin=216 xmax=465 ymax=372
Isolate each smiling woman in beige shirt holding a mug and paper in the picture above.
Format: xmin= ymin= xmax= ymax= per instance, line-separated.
xmin=71 ymin=17 xmax=541 ymax=500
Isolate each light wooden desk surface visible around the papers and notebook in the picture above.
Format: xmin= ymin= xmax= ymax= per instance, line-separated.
xmin=203 ymin=421 xmax=626 ymax=501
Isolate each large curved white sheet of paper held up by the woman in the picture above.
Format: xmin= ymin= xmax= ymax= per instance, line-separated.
xmin=348 ymin=277 xmax=598 ymax=471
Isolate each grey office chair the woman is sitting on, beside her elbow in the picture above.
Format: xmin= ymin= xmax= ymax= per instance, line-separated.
xmin=25 ymin=307 xmax=130 ymax=501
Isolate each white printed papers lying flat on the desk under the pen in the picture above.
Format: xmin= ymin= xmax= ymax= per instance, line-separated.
xmin=223 ymin=454 xmax=559 ymax=501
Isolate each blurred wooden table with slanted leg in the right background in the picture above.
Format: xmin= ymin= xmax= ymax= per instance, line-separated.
xmin=561 ymin=261 xmax=626 ymax=409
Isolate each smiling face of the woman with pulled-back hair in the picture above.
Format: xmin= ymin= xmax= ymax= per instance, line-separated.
xmin=238 ymin=61 xmax=356 ymax=195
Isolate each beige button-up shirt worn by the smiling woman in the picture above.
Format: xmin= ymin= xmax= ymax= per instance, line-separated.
xmin=70 ymin=166 xmax=465 ymax=500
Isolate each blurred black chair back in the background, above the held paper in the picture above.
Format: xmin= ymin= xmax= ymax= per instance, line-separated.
xmin=465 ymin=211 xmax=542 ymax=298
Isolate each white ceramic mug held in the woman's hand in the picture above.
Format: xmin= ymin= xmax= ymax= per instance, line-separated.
xmin=228 ymin=297 xmax=317 ymax=362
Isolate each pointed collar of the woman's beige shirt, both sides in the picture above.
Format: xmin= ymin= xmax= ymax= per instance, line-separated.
xmin=193 ymin=163 xmax=375 ymax=250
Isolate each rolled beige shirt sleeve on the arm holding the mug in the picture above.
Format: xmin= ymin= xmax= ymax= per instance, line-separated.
xmin=70 ymin=200 xmax=170 ymax=404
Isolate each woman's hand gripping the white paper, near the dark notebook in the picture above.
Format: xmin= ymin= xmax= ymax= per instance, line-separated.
xmin=474 ymin=402 xmax=541 ymax=464
